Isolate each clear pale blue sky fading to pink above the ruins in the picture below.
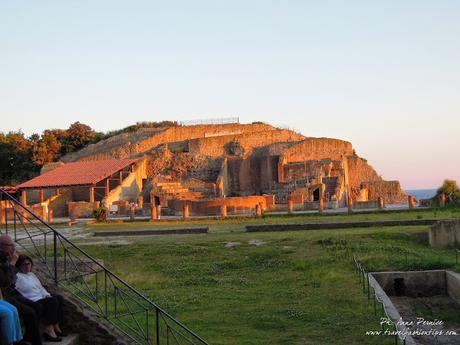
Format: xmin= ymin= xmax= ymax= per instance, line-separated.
xmin=0 ymin=0 xmax=460 ymax=188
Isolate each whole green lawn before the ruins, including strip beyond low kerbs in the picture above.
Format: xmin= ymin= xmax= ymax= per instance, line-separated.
xmin=74 ymin=218 xmax=460 ymax=345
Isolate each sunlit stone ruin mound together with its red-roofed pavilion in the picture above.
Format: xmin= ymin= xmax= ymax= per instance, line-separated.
xmin=9 ymin=123 xmax=407 ymax=219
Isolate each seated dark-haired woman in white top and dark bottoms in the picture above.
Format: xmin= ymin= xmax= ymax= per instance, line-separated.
xmin=16 ymin=255 xmax=66 ymax=342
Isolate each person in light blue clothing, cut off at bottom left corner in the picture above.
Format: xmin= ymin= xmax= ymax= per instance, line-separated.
xmin=0 ymin=290 xmax=22 ymax=345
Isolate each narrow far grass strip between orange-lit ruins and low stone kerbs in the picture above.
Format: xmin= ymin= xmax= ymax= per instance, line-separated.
xmin=87 ymin=208 xmax=460 ymax=232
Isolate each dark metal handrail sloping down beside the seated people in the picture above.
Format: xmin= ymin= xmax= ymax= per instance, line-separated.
xmin=0 ymin=188 xmax=209 ymax=345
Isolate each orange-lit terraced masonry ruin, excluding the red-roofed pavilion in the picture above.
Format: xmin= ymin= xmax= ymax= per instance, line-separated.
xmin=34 ymin=123 xmax=407 ymax=214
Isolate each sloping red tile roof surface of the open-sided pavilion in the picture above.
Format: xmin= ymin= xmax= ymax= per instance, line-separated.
xmin=16 ymin=159 xmax=136 ymax=189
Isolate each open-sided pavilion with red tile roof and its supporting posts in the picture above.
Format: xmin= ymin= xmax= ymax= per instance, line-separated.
xmin=16 ymin=159 xmax=136 ymax=204
